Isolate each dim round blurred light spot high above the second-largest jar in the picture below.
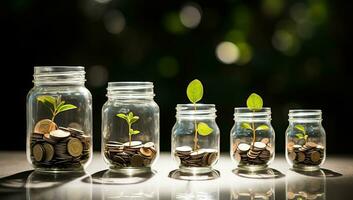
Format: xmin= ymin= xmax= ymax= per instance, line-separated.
xmin=104 ymin=10 xmax=125 ymax=34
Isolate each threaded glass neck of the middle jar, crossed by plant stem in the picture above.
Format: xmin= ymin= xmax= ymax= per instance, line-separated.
xmin=176 ymin=104 xmax=217 ymax=119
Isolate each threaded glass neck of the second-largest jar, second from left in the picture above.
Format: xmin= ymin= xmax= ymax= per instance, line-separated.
xmin=107 ymin=82 xmax=154 ymax=99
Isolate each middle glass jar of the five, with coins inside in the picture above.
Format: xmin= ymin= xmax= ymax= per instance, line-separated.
xmin=171 ymin=104 xmax=220 ymax=174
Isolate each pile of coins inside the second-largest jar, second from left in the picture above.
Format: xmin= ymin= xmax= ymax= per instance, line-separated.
xmin=104 ymin=141 xmax=157 ymax=167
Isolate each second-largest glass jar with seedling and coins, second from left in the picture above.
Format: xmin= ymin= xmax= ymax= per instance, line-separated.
xmin=102 ymin=82 xmax=159 ymax=172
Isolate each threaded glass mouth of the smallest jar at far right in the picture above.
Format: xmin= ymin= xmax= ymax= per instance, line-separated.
xmin=288 ymin=109 xmax=322 ymax=120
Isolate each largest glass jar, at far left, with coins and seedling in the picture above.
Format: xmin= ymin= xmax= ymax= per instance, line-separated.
xmin=27 ymin=66 xmax=92 ymax=171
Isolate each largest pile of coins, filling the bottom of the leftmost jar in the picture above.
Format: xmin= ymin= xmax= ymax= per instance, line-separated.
xmin=31 ymin=119 xmax=91 ymax=168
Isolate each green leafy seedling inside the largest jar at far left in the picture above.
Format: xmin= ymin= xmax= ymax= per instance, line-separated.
xmin=37 ymin=96 xmax=77 ymax=122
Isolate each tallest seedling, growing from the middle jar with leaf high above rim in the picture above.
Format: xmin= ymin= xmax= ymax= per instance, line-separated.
xmin=186 ymin=79 xmax=213 ymax=151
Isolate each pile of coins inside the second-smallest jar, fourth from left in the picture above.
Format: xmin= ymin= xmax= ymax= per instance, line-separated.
xmin=233 ymin=138 xmax=272 ymax=165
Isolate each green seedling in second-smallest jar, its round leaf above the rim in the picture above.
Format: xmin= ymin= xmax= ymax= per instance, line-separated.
xmin=241 ymin=93 xmax=270 ymax=145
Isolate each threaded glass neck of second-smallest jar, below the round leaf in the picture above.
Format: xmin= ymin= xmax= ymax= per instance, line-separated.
xmin=234 ymin=107 xmax=271 ymax=121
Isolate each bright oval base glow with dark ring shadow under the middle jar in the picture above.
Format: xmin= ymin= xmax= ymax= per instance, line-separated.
xmin=168 ymin=167 xmax=220 ymax=181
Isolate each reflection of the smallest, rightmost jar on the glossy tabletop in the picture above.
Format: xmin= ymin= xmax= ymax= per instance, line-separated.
xmin=286 ymin=170 xmax=326 ymax=200
